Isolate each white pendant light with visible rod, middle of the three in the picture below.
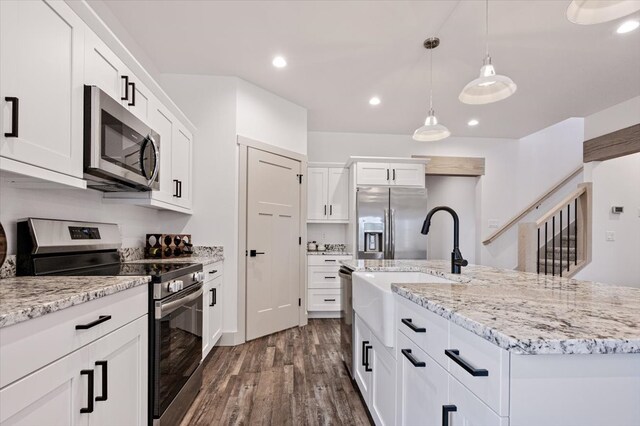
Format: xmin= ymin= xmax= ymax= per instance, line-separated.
xmin=458 ymin=0 xmax=518 ymax=105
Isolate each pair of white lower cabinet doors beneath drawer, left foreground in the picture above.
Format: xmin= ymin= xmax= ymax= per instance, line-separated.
xmin=0 ymin=315 xmax=149 ymax=426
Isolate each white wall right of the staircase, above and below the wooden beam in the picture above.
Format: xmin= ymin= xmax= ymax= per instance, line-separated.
xmin=576 ymin=97 xmax=640 ymax=287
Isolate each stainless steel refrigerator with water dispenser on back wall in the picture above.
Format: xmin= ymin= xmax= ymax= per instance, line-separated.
xmin=356 ymin=187 xmax=427 ymax=259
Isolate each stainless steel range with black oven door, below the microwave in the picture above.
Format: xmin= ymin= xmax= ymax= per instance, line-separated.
xmin=17 ymin=218 xmax=204 ymax=425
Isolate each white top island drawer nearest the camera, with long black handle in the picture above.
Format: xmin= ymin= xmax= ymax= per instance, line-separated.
xmin=447 ymin=324 xmax=509 ymax=416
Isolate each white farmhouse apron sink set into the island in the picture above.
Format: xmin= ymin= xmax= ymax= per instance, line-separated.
xmin=353 ymin=272 xmax=456 ymax=348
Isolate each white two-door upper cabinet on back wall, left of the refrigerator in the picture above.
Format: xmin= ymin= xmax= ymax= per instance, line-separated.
xmin=307 ymin=167 xmax=349 ymax=222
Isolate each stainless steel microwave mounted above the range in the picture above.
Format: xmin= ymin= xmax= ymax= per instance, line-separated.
xmin=84 ymin=86 xmax=160 ymax=192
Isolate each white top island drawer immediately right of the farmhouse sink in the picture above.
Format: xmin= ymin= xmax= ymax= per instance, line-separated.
xmin=395 ymin=296 xmax=449 ymax=369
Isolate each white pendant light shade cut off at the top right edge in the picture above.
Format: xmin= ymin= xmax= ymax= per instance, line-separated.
xmin=567 ymin=0 xmax=640 ymax=25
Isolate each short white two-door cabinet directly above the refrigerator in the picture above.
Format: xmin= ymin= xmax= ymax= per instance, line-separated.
xmin=356 ymin=161 xmax=425 ymax=188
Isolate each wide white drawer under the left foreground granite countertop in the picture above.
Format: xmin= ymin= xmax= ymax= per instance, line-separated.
xmin=0 ymin=285 xmax=149 ymax=388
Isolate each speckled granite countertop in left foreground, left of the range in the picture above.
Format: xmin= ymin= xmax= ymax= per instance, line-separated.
xmin=0 ymin=276 xmax=150 ymax=328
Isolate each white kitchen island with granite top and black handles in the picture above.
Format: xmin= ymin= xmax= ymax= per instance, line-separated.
xmin=343 ymin=260 xmax=640 ymax=426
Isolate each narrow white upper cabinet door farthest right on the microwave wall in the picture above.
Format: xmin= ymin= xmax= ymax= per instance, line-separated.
xmin=171 ymin=126 xmax=193 ymax=208
